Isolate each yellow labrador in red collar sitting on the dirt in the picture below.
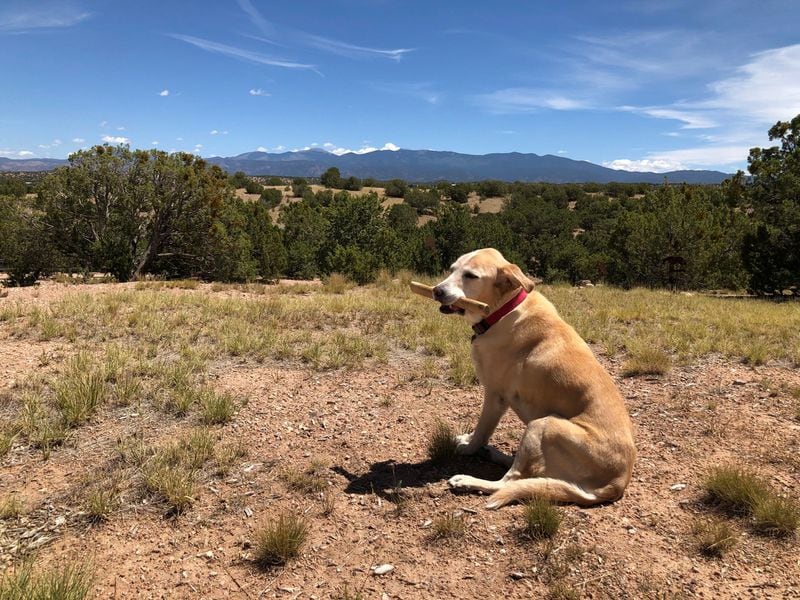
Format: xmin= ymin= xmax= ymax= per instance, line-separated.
xmin=434 ymin=248 xmax=636 ymax=508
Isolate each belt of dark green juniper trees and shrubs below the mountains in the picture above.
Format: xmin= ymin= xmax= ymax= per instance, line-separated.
xmin=0 ymin=116 xmax=800 ymax=295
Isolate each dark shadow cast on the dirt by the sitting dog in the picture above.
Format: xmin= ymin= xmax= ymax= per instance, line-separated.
xmin=331 ymin=450 xmax=507 ymax=501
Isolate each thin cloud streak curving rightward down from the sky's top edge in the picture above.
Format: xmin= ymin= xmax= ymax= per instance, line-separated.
xmin=238 ymin=0 xmax=416 ymax=62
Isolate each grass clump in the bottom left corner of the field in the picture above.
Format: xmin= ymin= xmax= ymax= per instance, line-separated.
xmin=0 ymin=562 xmax=94 ymax=600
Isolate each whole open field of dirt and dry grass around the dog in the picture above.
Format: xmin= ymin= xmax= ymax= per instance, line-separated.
xmin=0 ymin=276 xmax=800 ymax=599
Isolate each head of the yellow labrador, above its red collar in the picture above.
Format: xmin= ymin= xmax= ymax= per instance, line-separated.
xmin=433 ymin=248 xmax=533 ymax=322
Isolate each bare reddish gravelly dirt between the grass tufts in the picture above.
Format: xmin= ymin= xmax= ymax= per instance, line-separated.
xmin=0 ymin=284 xmax=800 ymax=599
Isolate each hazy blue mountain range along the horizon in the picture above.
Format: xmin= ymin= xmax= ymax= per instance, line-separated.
xmin=0 ymin=150 xmax=730 ymax=183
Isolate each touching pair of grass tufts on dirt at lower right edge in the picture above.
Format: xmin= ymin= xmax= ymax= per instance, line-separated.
xmin=704 ymin=467 xmax=800 ymax=537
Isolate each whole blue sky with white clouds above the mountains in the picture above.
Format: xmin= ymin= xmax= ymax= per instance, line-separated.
xmin=0 ymin=0 xmax=800 ymax=171
